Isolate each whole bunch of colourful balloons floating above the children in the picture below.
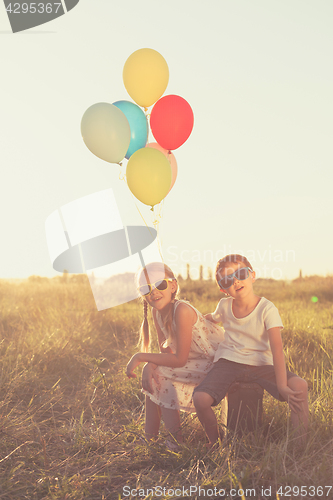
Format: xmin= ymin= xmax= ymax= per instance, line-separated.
xmin=81 ymin=49 xmax=194 ymax=208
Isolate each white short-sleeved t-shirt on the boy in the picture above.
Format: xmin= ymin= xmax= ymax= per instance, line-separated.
xmin=212 ymin=297 xmax=283 ymax=366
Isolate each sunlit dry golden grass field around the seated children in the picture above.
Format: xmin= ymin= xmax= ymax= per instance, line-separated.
xmin=0 ymin=277 xmax=333 ymax=500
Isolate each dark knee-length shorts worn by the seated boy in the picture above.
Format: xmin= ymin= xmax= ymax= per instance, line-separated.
xmin=193 ymin=358 xmax=297 ymax=406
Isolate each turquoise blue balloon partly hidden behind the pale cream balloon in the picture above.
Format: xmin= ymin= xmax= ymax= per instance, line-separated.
xmin=113 ymin=101 xmax=148 ymax=159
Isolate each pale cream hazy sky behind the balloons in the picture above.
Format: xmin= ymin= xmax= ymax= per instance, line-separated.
xmin=0 ymin=0 xmax=333 ymax=279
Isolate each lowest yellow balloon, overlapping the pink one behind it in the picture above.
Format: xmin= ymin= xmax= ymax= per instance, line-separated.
xmin=126 ymin=148 xmax=172 ymax=207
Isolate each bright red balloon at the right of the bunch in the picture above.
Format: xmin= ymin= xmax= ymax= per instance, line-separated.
xmin=150 ymin=95 xmax=194 ymax=150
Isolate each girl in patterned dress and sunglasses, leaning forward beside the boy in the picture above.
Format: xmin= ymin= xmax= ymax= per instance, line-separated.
xmin=126 ymin=262 xmax=224 ymax=447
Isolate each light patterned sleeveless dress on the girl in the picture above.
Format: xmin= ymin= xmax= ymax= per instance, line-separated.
xmin=142 ymin=300 xmax=224 ymax=412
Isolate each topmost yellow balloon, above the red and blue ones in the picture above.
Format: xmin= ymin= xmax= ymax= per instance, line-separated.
xmin=123 ymin=49 xmax=169 ymax=107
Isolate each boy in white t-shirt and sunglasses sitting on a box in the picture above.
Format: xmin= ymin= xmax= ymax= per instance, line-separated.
xmin=193 ymin=254 xmax=308 ymax=446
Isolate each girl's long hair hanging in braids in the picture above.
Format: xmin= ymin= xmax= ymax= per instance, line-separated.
xmin=137 ymin=262 xmax=178 ymax=352
